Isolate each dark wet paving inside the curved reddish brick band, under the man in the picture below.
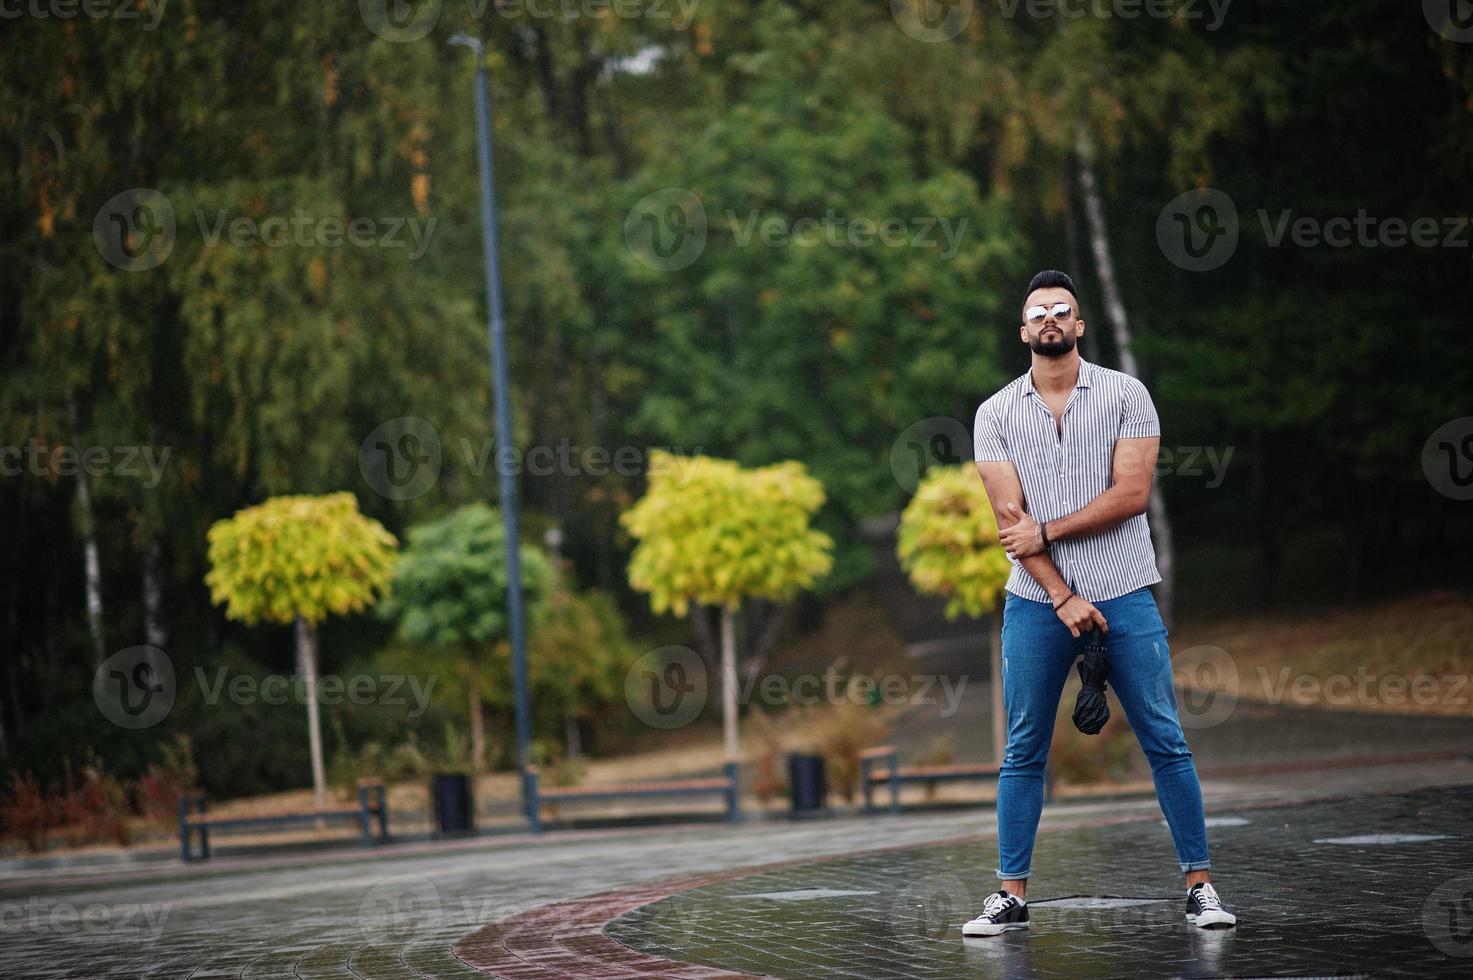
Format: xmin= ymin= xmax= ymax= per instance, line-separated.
xmin=604 ymin=788 xmax=1473 ymax=979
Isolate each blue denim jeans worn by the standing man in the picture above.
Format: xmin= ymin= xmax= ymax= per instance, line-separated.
xmin=997 ymin=588 xmax=1211 ymax=880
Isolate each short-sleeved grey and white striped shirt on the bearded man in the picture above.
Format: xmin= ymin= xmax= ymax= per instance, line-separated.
xmin=972 ymin=358 xmax=1161 ymax=603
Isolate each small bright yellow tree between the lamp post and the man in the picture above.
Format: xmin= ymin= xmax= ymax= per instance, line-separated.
xmin=620 ymin=452 xmax=834 ymax=759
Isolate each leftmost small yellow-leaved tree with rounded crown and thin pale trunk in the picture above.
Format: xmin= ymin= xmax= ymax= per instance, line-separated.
xmin=205 ymin=494 xmax=398 ymax=808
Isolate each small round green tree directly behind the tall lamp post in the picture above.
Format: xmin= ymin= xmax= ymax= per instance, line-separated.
xmin=380 ymin=503 xmax=552 ymax=771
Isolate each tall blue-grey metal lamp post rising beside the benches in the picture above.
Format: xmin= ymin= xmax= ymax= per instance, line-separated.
xmin=451 ymin=34 xmax=536 ymax=827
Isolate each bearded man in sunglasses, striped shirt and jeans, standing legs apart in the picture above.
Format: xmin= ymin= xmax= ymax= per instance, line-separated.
xmin=962 ymin=271 xmax=1237 ymax=936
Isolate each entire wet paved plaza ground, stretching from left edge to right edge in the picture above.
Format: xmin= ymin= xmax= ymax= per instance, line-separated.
xmin=0 ymin=765 xmax=1473 ymax=980
